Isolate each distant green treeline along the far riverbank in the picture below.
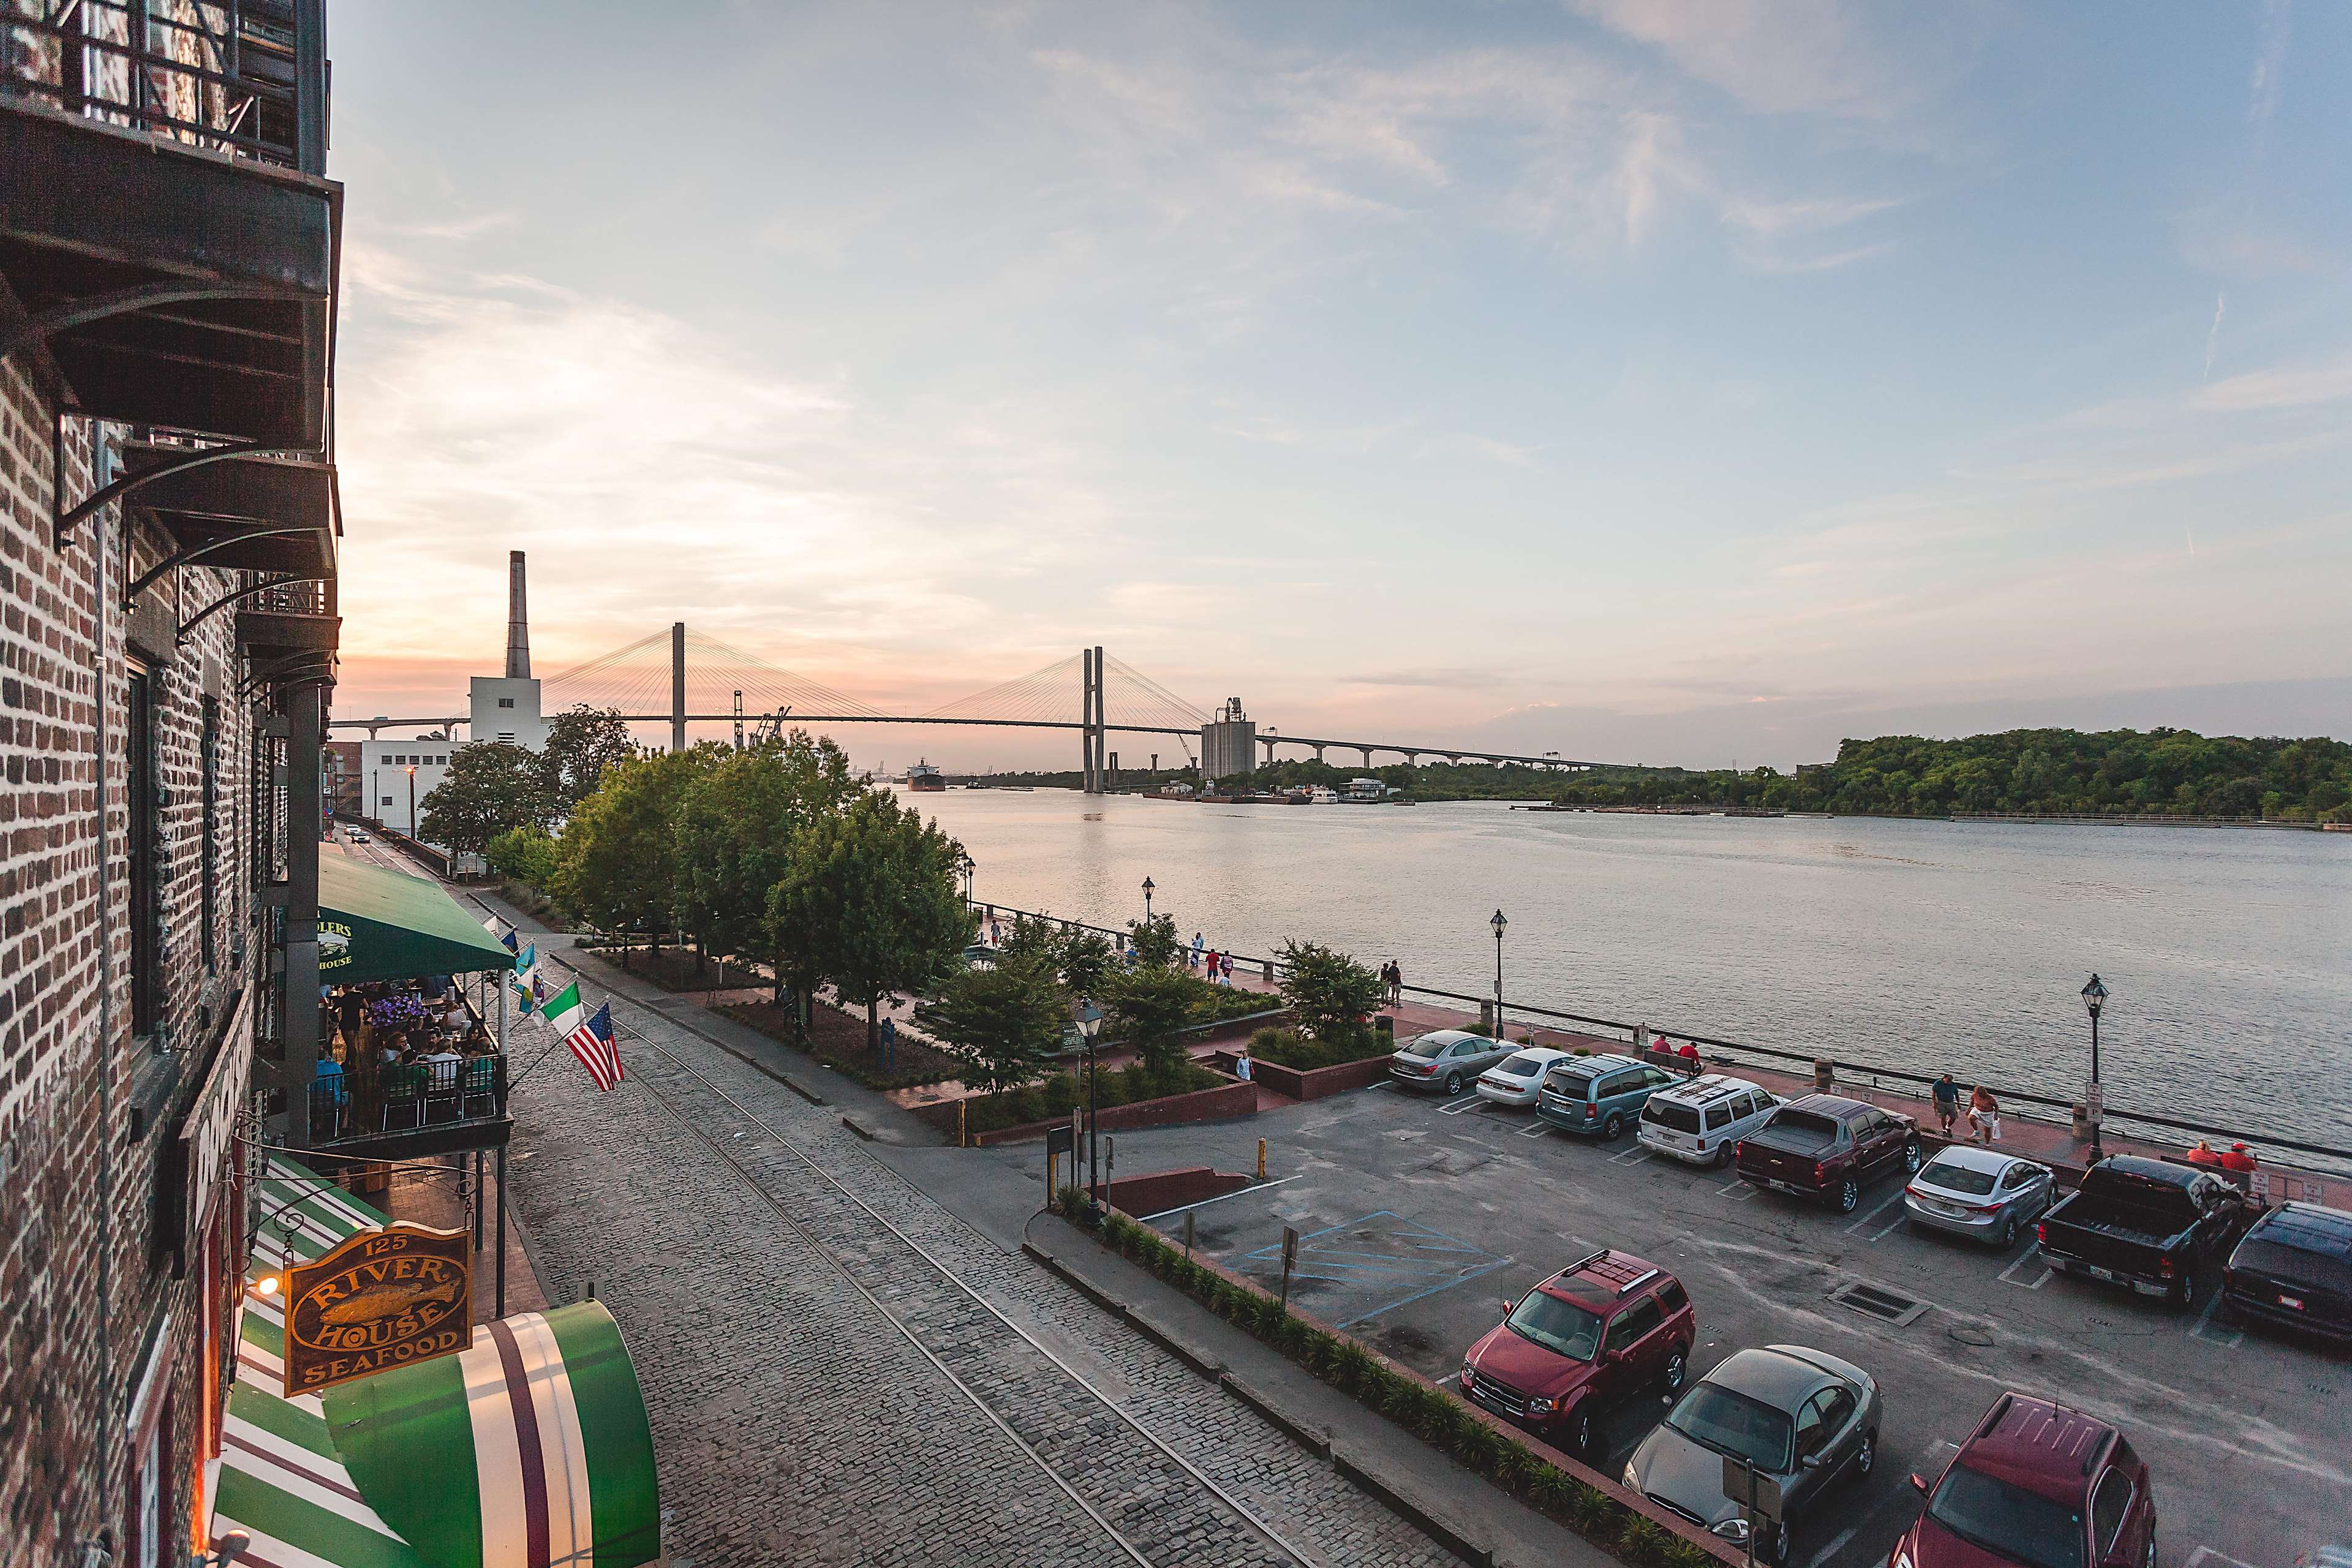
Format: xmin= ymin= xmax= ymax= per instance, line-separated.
xmin=969 ymin=729 xmax=2352 ymax=823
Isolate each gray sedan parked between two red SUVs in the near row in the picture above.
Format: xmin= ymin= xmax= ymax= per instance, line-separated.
xmin=1625 ymin=1344 xmax=1884 ymax=1563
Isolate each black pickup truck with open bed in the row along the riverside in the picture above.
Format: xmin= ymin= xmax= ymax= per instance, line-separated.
xmin=2037 ymin=1154 xmax=2260 ymax=1307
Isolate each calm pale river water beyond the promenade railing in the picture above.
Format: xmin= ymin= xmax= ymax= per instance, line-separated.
xmin=908 ymin=790 xmax=2352 ymax=1147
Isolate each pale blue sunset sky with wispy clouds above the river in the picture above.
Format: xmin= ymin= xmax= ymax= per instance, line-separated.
xmin=330 ymin=0 xmax=2352 ymax=769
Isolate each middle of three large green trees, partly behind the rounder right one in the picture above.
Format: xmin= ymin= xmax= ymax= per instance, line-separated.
xmin=675 ymin=729 xmax=859 ymax=992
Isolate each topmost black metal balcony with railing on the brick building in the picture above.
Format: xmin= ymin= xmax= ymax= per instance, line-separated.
xmin=0 ymin=0 xmax=341 ymax=451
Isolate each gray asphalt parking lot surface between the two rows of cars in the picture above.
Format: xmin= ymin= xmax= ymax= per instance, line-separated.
xmin=1020 ymin=1086 xmax=2352 ymax=1568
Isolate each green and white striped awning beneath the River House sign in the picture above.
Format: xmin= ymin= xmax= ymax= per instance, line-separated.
xmin=212 ymin=1159 xmax=661 ymax=1568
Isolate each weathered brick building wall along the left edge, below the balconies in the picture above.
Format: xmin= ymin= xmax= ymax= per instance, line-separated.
xmin=0 ymin=355 xmax=261 ymax=1566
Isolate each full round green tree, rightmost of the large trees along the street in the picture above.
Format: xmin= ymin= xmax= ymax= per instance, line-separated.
xmin=769 ymin=792 xmax=976 ymax=1051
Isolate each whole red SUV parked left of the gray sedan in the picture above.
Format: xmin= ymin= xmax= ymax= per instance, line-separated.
xmin=1461 ymin=1251 xmax=1698 ymax=1455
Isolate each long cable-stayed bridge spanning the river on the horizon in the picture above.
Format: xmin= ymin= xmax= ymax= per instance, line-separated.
xmin=334 ymin=623 xmax=1604 ymax=788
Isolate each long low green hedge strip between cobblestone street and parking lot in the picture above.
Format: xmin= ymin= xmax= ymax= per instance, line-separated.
xmin=1061 ymin=1187 xmax=1719 ymax=1568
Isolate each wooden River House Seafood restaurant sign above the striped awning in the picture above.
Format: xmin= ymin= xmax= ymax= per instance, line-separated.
xmin=287 ymin=1220 xmax=473 ymax=1399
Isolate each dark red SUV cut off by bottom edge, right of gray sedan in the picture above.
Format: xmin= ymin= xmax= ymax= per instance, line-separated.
xmin=1887 ymin=1394 xmax=2157 ymax=1568
